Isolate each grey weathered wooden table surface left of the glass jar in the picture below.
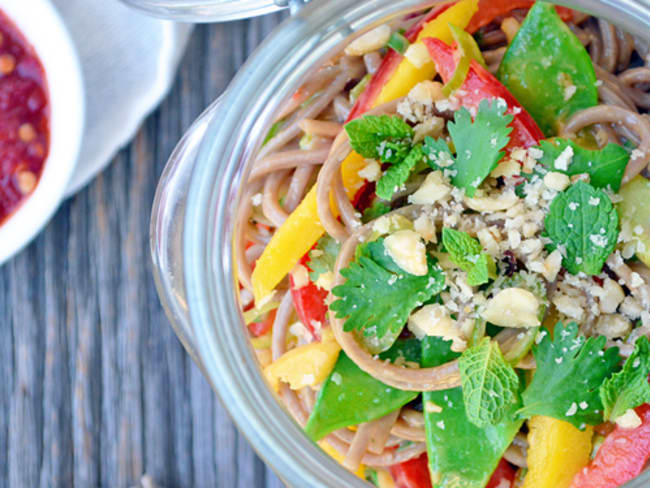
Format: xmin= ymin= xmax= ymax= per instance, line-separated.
xmin=0 ymin=15 xmax=282 ymax=488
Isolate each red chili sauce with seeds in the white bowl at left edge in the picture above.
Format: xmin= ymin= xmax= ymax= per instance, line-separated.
xmin=0 ymin=11 xmax=50 ymax=224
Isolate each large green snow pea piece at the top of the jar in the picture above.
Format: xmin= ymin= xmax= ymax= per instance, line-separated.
xmin=497 ymin=2 xmax=598 ymax=136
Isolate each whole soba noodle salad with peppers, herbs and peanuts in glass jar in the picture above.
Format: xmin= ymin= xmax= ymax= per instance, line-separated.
xmin=235 ymin=0 xmax=650 ymax=488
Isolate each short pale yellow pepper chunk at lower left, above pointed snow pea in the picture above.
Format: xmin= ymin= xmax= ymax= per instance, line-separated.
xmin=264 ymin=328 xmax=341 ymax=391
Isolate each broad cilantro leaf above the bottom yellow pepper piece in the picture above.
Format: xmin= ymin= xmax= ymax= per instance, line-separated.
xmin=518 ymin=322 xmax=619 ymax=428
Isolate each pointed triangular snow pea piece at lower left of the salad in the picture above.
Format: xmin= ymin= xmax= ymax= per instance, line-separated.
xmin=305 ymin=339 xmax=420 ymax=441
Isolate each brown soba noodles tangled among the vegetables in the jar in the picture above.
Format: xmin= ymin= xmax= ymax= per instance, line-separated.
xmin=235 ymin=3 xmax=650 ymax=476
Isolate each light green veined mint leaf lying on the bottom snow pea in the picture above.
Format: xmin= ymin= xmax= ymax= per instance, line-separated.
xmin=458 ymin=337 xmax=519 ymax=427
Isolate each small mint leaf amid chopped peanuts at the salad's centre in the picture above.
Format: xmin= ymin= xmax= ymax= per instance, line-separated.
xmin=442 ymin=227 xmax=496 ymax=286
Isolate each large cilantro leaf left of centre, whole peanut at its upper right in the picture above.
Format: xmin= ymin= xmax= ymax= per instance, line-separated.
xmin=330 ymin=238 xmax=445 ymax=348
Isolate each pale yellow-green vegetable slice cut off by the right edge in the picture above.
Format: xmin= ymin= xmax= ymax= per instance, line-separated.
xmin=616 ymin=176 xmax=650 ymax=266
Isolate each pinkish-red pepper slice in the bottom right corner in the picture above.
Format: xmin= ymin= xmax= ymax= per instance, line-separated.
xmin=571 ymin=403 xmax=650 ymax=488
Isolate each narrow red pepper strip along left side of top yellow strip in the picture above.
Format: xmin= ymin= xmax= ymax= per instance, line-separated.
xmin=346 ymin=2 xmax=455 ymax=122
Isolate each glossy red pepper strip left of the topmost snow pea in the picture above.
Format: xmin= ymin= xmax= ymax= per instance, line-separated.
xmin=422 ymin=37 xmax=544 ymax=150
